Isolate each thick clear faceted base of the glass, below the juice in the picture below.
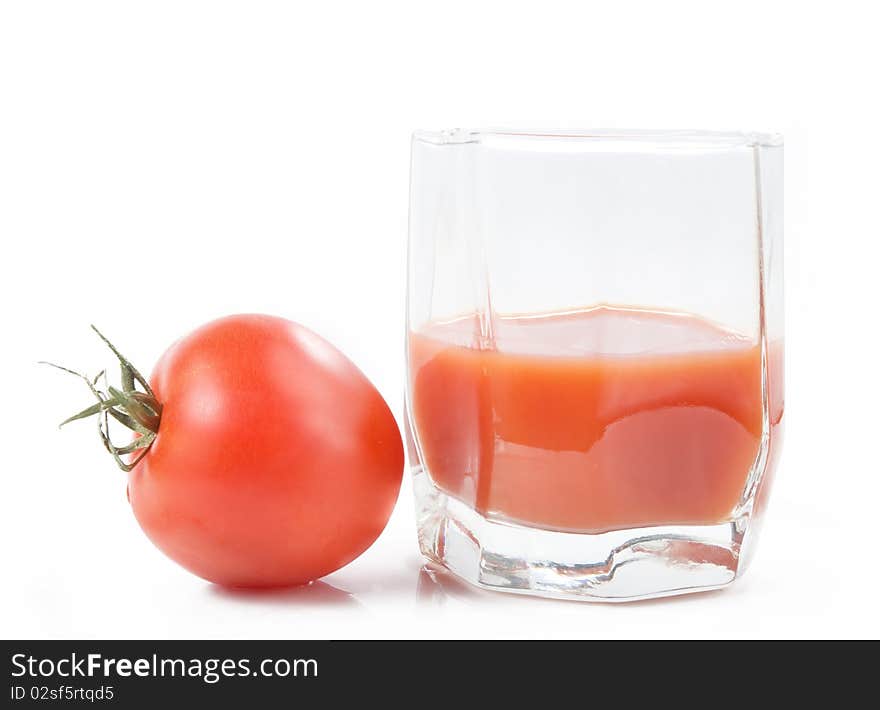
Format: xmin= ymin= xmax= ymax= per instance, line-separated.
xmin=413 ymin=466 xmax=749 ymax=602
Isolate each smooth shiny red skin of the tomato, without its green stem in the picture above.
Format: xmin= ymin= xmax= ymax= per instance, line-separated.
xmin=129 ymin=315 xmax=403 ymax=587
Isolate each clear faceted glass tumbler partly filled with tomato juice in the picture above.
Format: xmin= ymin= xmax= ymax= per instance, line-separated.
xmin=407 ymin=130 xmax=783 ymax=601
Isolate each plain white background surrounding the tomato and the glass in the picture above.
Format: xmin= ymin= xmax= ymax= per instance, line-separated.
xmin=0 ymin=0 xmax=880 ymax=638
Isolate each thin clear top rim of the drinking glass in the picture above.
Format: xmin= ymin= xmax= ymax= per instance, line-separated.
xmin=412 ymin=128 xmax=783 ymax=150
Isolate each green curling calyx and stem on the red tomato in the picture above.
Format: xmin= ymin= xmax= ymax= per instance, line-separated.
xmin=42 ymin=326 xmax=162 ymax=472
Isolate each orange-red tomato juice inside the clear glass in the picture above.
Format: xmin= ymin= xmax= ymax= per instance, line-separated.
xmin=409 ymin=306 xmax=780 ymax=532
